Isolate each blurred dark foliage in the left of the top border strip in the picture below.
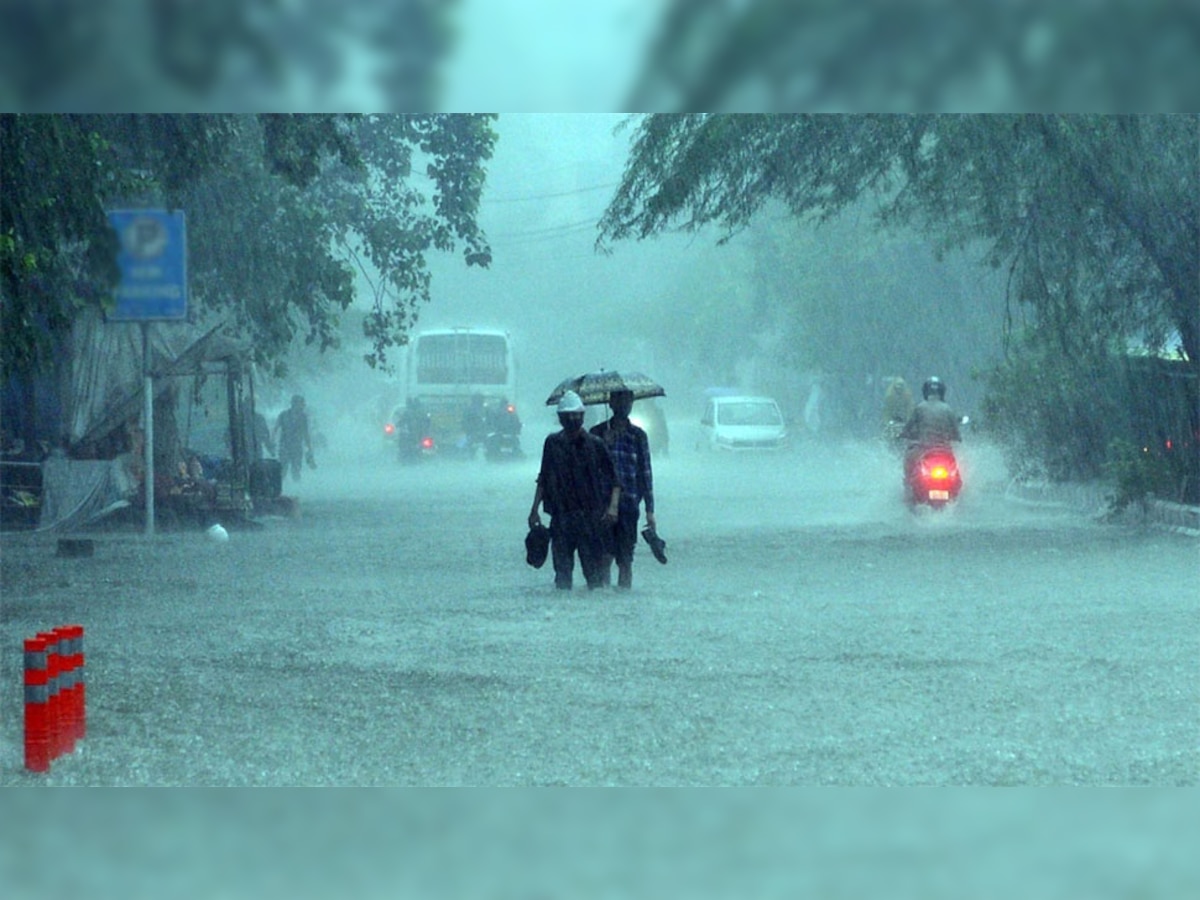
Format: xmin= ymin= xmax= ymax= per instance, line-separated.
xmin=0 ymin=0 xmax=457 ymax=112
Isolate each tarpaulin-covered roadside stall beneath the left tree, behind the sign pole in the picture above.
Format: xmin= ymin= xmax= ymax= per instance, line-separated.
xmin=38 ymin=322 xmax=289 ymax=530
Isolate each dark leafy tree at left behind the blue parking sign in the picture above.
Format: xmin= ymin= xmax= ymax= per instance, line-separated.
xmin=0 ymin=115 xmax=496 ymax=377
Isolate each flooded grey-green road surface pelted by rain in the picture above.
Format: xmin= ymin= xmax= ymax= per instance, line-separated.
xmin=0 ymin=439 xmax=1200 ymax=785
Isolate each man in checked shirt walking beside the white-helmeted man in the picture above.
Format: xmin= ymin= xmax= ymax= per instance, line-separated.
xmin=592 ymin=391 xmax=658 ymax=590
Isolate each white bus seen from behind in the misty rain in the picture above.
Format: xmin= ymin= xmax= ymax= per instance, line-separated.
xmin=394 ymin=326 xmax=517 ymax=452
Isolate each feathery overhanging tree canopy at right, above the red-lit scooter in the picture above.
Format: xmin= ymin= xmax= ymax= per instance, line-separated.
xmin=599 ymin=115 xmax=1200 ymax=496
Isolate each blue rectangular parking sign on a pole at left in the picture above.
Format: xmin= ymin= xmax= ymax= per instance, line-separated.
xmin=108 ymin=209 xmax=187 ymax=322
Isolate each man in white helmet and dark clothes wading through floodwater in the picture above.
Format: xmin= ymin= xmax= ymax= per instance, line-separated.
xmin=529 ymin=391 xmax=620 ymax=590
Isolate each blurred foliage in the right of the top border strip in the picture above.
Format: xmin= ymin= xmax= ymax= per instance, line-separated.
xmin=624 ymin=0 xmax=1200 ymax=112
